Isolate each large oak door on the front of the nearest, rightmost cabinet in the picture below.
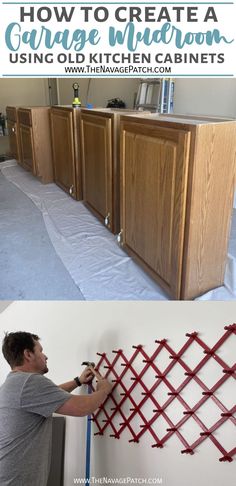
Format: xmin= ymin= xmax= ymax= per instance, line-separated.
xmin=121 ymin=122 xmax=190 ymax=298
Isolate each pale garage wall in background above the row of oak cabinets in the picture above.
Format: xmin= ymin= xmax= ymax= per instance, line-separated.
xmin=0 ymin=78 xmax=236 ymax=117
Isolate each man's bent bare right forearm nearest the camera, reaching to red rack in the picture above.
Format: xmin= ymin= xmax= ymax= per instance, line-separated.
xmin=55 ymin=378 xmax=112 ymax=417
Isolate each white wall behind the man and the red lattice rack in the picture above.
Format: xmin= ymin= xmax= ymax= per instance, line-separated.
xmin=0 ymin=302 xmax=236 ymax=486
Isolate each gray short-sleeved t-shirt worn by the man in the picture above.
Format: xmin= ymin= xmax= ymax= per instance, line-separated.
xmin=0 ymin=371 xmax=71 ymax=486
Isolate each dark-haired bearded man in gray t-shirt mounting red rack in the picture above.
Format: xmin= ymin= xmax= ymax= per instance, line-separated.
xmin=0 ymin=332 xmax=112 ymax=486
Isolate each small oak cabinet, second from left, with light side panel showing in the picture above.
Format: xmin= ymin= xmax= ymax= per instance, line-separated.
xmin=18 ymin=106 xmax=53 ymax=183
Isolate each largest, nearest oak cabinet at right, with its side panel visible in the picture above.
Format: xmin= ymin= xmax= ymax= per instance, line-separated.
xmin=119 ymin=114 xmax=236 ymax=299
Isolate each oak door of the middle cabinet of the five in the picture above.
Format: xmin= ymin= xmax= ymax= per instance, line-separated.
xmin=51 ymin=109 xmax=76 ymax=198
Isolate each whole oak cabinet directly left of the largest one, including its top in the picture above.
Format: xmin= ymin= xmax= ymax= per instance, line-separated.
xmin=81 ymin=108 xmax=151 ymax=233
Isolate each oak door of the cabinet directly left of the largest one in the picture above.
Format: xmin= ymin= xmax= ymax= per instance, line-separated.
xmin=81 ymin=114 xmax=113 ymax=230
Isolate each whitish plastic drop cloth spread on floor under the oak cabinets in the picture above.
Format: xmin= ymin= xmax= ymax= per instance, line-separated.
xmin=1 ymin=160 xmax=236 ymax=300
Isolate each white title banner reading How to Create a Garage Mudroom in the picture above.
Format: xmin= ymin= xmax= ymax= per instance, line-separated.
xmin=0 ymin=2 xmax=236 ymax=78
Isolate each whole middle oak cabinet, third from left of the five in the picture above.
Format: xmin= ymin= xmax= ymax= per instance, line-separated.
xmin=50 ymin=106 xmax=83 ymax=200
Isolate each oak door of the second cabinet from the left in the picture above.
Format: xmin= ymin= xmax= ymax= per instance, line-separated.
xmin=19 ymin=125 xmax=37 ymax=175
